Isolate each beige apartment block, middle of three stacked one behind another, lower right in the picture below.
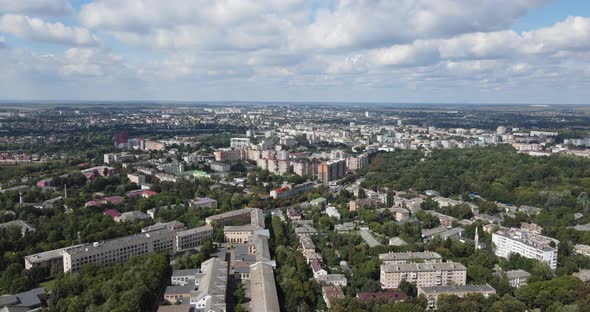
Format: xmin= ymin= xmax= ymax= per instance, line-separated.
xmin=380 ymin=262 xmax=467 ymax=289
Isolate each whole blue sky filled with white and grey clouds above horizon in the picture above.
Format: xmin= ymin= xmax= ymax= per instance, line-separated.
xmin=0 ymin=0 xmax=590 ymax=104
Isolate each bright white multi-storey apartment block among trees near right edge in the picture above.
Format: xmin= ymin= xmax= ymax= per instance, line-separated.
xmin=492 ymin=228 xmax=559 ymax=270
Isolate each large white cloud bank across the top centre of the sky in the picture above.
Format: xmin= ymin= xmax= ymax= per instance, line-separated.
xmin=80 ymin=0 xmax=547 ymax=51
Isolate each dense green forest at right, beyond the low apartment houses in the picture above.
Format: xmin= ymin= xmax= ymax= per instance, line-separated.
xmin=363 ymin=145 xmax=590 ymax=208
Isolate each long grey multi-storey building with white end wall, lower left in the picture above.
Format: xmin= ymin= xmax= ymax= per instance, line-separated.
xmin=63 ymin=229 xmax=176 ymax=272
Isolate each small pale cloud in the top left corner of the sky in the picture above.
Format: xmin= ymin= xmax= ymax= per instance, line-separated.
xmin=0 ymin=0 xmax=74 ymax=16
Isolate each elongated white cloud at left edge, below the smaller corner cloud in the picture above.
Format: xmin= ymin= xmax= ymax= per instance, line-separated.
xmin=0 ymin=14 xmax=98 ymax=46
